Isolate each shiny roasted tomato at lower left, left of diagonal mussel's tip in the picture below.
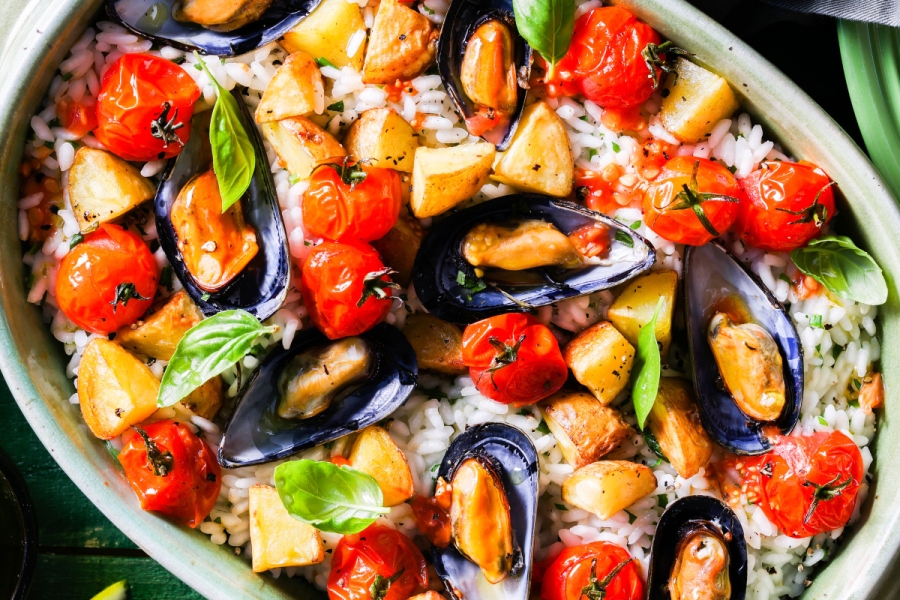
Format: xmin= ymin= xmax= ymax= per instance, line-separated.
xmin=119 ymin=420 xmax=222 ymax=527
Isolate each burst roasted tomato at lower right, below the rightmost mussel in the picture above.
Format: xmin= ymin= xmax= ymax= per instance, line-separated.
xmin=755 ymin=431 xmax=865 ymax=538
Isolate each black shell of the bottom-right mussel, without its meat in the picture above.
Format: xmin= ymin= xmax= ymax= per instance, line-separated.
xmin=647 ymin=496 xmax=747 ymax=600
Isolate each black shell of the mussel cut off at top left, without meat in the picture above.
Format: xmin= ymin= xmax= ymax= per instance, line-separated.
xmin=106 ymin=0 xmax=321 ymax=56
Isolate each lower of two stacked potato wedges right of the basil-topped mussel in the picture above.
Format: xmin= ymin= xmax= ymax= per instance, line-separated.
xmin=262 ymin=117 xmax=347 ymax=179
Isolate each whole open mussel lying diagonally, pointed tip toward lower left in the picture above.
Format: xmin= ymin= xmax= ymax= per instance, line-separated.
xmin=219 ymin=323 xmax=418 ymax=468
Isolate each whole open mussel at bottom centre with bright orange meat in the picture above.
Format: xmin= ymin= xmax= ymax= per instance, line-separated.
xmin=432 ymin=423 xmax=538 ymax=600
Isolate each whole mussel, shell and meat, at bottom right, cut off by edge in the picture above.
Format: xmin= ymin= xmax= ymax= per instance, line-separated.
xmin=647 ymin=496 xmax=747 ymax=600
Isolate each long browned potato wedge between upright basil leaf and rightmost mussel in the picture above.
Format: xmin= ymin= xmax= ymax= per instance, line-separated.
xmin=647 ymin=377 xmax=713 ymax=479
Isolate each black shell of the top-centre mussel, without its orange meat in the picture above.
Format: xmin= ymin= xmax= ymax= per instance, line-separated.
xmin=437 ymin=0 xmax=531 ymax=150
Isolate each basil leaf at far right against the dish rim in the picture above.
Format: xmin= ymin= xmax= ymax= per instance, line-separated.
xmin=791 ymin=235 xmax=888 ymax=306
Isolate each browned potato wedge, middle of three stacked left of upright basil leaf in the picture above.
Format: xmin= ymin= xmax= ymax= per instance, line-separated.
xmin=539 ymin=390 xmax=634 ymax=469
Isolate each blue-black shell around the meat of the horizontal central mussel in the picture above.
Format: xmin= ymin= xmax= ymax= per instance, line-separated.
xmin=413 ymin=194 xmax=656 ymax=324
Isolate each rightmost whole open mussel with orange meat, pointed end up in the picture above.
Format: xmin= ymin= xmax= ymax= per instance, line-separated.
xmin=684 ymin=242 xmax=803 ymax=455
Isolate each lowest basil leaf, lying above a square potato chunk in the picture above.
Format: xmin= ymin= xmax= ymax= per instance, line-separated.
xmin=275 ymin=460 xmax=391 ymax=534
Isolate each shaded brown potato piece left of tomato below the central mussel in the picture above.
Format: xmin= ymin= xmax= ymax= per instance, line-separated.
xmin=403 ymin=313 xmax=468 ymax=375
